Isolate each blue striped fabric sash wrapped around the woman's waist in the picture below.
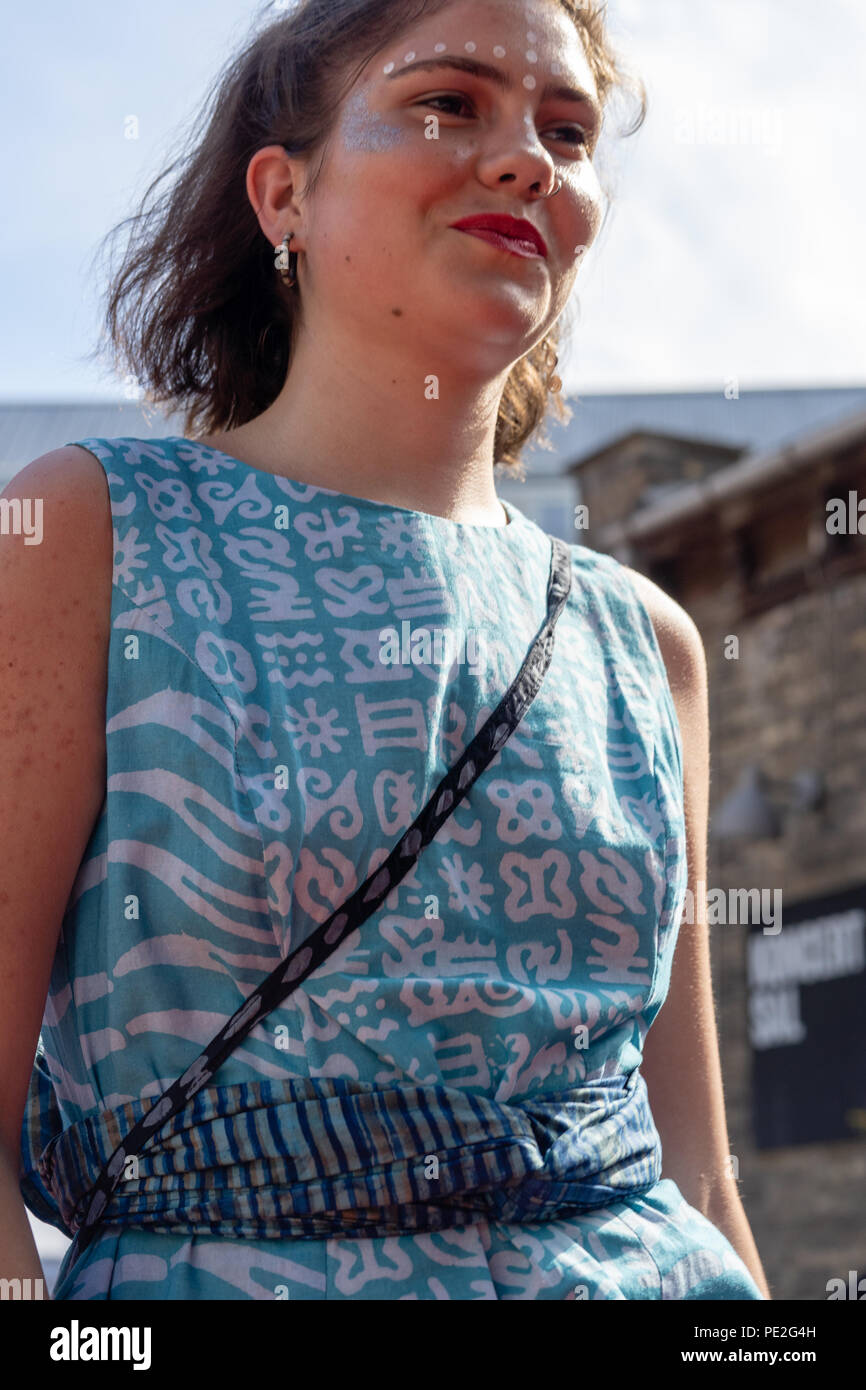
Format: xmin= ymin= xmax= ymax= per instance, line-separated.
xmin=38 ymin=1069 xmax=662 ymax=1240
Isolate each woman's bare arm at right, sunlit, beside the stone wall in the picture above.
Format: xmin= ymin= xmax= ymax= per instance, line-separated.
xmin=628 ymin=570 xmax=770 ymax=1298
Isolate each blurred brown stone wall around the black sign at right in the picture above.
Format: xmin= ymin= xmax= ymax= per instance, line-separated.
xmin=677 ymin=547 xmax=866 ymax=1300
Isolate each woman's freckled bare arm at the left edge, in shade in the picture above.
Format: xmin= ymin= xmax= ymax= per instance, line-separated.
xmin=0 ymin=446 xmax=114 ymax=1279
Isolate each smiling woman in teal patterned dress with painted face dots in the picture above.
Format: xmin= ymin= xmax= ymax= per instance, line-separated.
xmin=1 ymin=0 xmax=769 ymax=1300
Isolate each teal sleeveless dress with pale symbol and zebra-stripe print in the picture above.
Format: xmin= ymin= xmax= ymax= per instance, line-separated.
xmin=21 ymin=436 xmax=762 ymax=1300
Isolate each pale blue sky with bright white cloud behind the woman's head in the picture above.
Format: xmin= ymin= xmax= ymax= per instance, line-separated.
xmin=0 ymin=0 xmax=866 ymax=402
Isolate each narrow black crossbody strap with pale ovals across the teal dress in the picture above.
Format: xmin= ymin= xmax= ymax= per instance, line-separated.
xmin=75 ymin=537 xmax=571 ymax=1258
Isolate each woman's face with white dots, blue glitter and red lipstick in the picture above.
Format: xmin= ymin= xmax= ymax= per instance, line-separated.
xmin=287 ymin=0 xmax=602 ymax=371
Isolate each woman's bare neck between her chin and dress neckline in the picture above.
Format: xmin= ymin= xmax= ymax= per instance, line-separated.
xmin=207 ymin=318 xmax=510 ymax=525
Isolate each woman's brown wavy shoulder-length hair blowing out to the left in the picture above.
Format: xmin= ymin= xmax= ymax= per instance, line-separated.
xmin=89 ymin=0 xmax=646 ymax=475
